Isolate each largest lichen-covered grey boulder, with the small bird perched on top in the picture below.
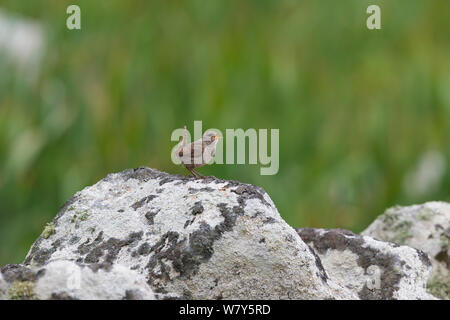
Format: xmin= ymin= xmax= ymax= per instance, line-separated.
xmin=15 ymin=168 xmax=357 ymax=299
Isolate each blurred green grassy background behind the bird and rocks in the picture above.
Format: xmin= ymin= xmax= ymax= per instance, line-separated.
xmin=0 ymin=0 xmax=450 ymax=265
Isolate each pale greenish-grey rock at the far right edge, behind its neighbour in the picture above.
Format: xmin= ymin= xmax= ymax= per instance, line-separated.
xmin=362 ymin=202 xmax=450 ymax=299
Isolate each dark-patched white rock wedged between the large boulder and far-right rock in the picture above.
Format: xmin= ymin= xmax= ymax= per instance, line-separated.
xmin=297 ymin=228 xmax=434 ymax=300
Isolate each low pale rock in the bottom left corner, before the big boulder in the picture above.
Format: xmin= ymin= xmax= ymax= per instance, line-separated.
xmin=1 ymin=260 xmax=154 ymax=300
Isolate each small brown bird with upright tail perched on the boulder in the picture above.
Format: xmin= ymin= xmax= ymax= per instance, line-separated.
xmin=176 ymin=126 xmax=220 ymax=179
